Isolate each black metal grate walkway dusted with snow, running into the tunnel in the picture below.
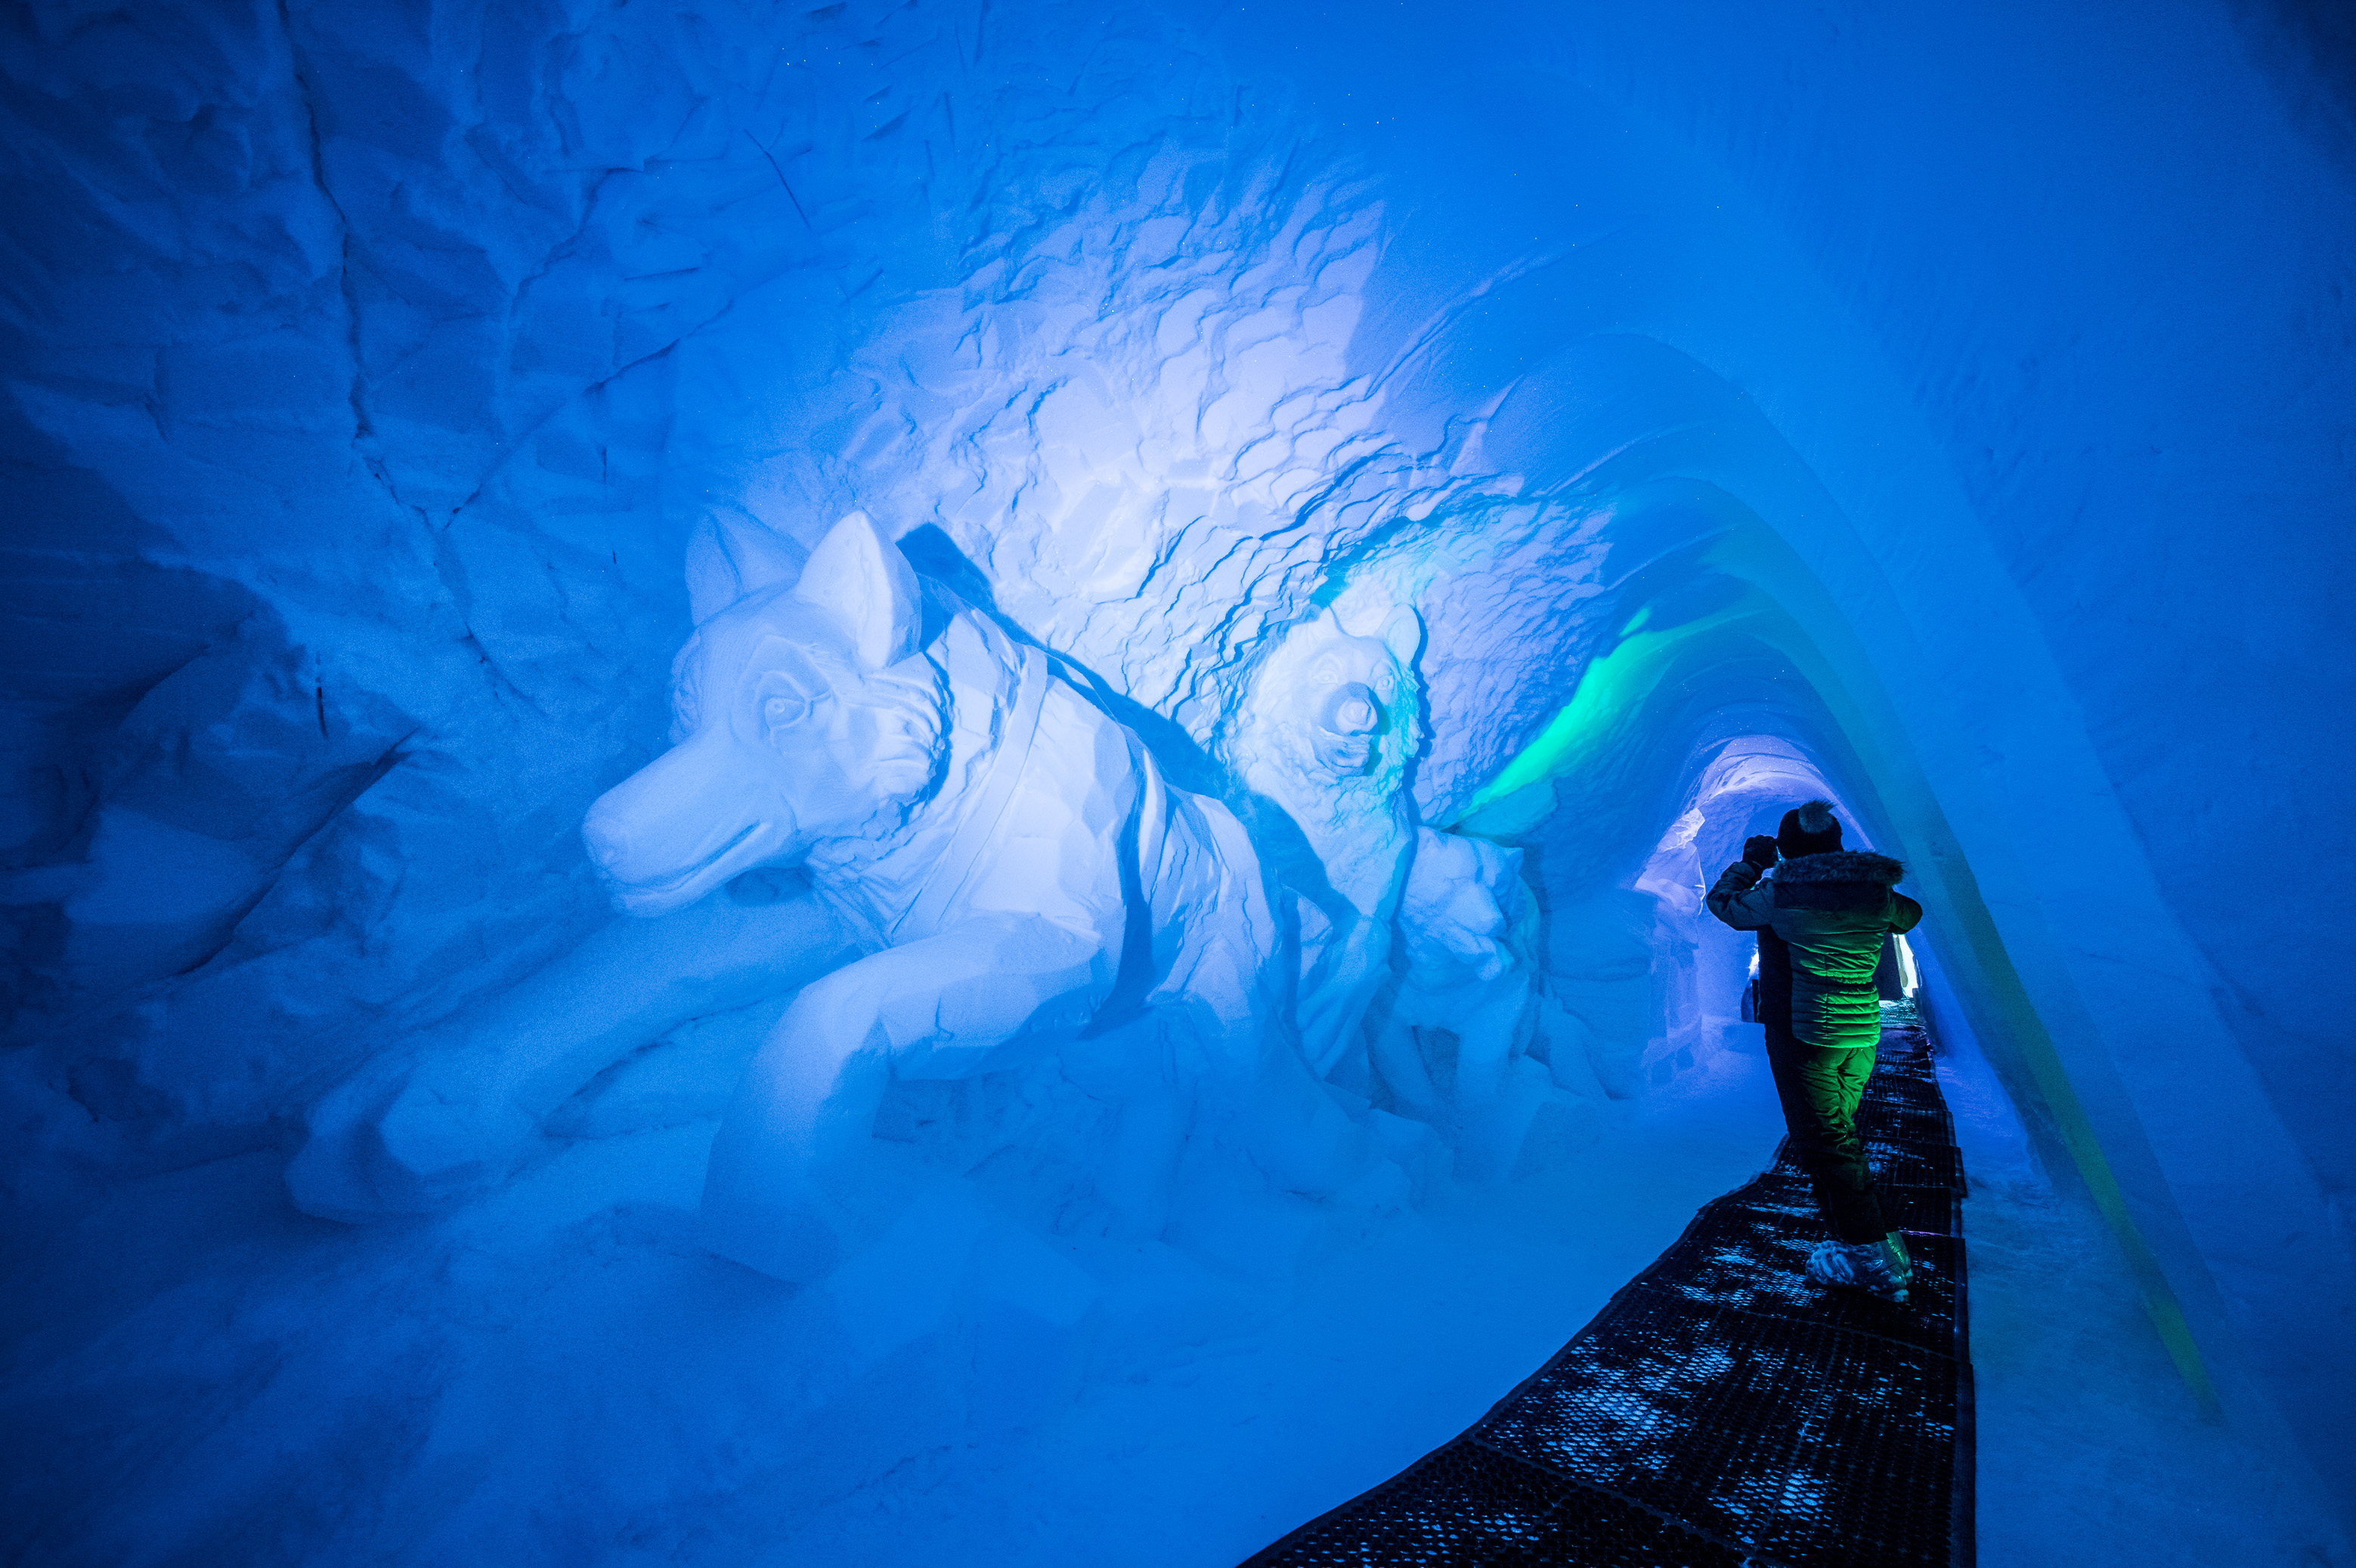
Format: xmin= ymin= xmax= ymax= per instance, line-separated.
xmin=1244 ymin=1003 xmax=1972 ymax=1568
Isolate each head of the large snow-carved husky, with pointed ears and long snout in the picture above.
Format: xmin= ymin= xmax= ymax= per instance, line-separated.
xmin=582 ymin=513 xmax=947 ymax=916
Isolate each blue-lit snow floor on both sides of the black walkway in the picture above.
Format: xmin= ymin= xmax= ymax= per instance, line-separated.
xmin=0 ymin=1026 xmax=2351 ymax=1568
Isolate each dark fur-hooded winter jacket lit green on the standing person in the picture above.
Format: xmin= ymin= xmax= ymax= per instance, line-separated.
xmin=1710 ymin=850 xmax=1922 ymax=1047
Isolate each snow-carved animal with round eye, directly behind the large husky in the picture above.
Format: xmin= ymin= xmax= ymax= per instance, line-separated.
xmin=1228 ymin=608 xmax=1423 ymax=1076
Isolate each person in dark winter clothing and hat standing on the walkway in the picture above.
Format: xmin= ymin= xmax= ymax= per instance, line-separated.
xmin=1708 ymin=800 xmax=1922 ymax=1302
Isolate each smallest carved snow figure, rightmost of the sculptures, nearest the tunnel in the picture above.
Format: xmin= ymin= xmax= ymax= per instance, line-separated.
xmin=1367 ymin=829 xmax=1548 ymax=1180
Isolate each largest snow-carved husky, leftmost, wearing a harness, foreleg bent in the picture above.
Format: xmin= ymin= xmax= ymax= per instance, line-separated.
xmin=582 ymin=513 xmax=1362 ymax=1281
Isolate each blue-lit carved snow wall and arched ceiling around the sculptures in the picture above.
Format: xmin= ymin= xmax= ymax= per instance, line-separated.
xmin=5 ymin=0 xmax=2356 ymax=1495
